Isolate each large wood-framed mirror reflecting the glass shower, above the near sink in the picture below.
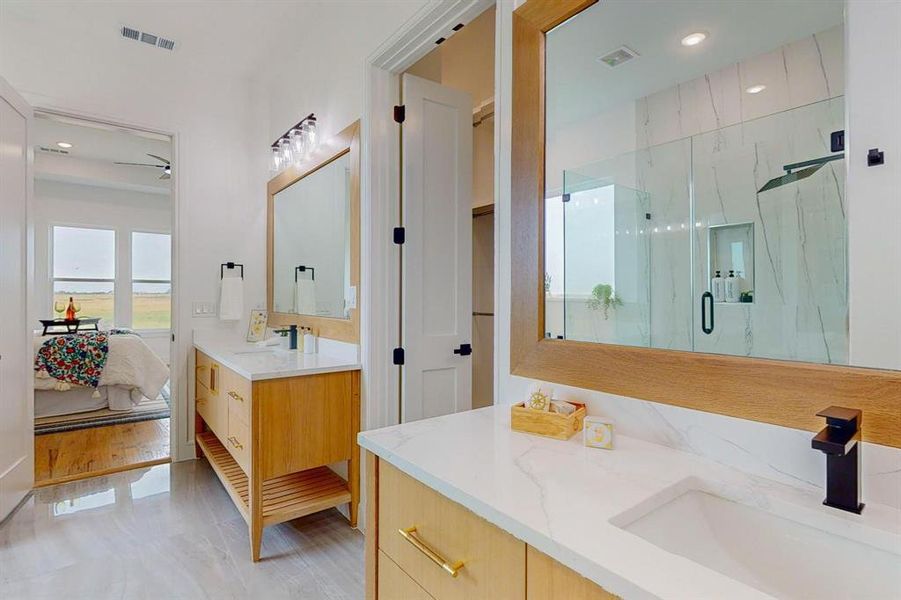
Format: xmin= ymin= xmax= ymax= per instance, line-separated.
xmin=510 ymin=0 xmax=901 ymax=446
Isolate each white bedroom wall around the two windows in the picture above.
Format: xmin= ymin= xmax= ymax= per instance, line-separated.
xmin=32 ymin=179 xmax=172 ymax=363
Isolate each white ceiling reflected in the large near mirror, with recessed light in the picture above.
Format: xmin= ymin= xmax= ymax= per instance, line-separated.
xmin=547 ymin=0 xmax=844 ymax=127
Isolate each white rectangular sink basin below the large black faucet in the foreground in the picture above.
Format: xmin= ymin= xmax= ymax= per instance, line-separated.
xmin=611 ymin=478 xmax=901 ymax=600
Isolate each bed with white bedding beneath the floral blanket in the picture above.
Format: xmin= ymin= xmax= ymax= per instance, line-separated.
xmin=34 ymin=334 xmax=169 ymax=418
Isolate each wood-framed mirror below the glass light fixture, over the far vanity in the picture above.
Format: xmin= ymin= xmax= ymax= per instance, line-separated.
xmin=266 ymin=121 xmax=360 ymax=343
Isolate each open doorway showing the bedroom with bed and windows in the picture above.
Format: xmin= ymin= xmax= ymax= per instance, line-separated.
xmin=32 ymin=112 xmax=175 ymax=486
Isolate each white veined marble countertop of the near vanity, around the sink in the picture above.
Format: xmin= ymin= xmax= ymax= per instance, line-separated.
xmin=359 ymin=406 xmax=901 ymax=600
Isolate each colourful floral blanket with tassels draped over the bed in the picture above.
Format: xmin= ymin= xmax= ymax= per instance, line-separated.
xmin=34 ymin=331 xmax=109 ymax=388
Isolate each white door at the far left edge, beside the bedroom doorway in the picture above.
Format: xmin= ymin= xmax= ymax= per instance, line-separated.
xmin=0 ymin=78 xmax=34 ymax=520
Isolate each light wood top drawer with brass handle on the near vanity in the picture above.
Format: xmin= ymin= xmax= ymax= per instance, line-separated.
xmin=378 ymin=461 xmax=526 ymax=600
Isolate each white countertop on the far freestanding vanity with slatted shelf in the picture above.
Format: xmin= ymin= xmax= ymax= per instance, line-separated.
xmin=194 ymin=338 xmax=361 ymax=381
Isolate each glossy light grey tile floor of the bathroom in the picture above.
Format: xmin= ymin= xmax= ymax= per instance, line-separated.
xmin=0 ymin=460 xmax=363 ymax=600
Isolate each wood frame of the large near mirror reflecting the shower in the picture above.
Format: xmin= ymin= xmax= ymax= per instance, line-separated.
xmin=510 ymin=0 xmax=901 ymax=447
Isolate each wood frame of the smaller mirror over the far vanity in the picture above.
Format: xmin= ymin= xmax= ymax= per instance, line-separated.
xmin=266 ymin=120 xmax=361 ymax=344
